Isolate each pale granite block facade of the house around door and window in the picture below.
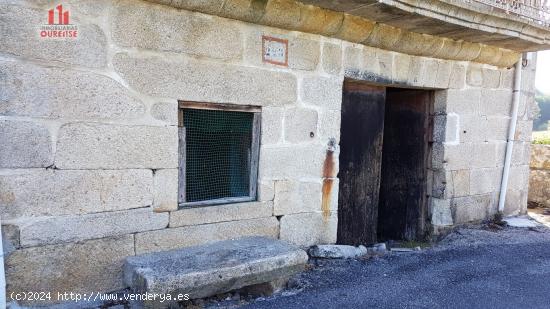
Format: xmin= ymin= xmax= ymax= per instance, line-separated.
xmin=0 ymin=0 xmax=550 ymax=302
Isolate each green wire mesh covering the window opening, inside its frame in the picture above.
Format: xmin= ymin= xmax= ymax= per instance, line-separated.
xmin=183 ymin=108 xmax=253 ymax=202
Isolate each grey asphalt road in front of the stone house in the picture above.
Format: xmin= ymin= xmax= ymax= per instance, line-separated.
xmin=244 ymin=228 xmax=550 ymax=309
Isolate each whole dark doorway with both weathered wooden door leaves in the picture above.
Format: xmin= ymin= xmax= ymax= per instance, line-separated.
xmin=337 ymin=80 xmax=433 ymax=245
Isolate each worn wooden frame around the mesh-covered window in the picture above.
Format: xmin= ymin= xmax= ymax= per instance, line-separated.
xmin=178 ymin=101 xmax=261 ymax=208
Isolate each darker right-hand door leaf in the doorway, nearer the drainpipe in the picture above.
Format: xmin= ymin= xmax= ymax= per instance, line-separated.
xmin=378 ymin=88 xmax=431 ymax=241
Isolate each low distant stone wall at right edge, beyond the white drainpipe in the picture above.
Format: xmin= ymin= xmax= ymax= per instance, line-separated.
xmin=529 ymin=145 xmax=550 ymax=208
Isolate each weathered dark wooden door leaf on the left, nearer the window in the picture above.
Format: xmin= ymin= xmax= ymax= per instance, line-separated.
xmin=337 ymin=82 xmax=386 ymax=245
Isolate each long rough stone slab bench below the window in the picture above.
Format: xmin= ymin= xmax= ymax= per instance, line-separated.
xmin=124 ymin=237 xmax=308 ymax=307
